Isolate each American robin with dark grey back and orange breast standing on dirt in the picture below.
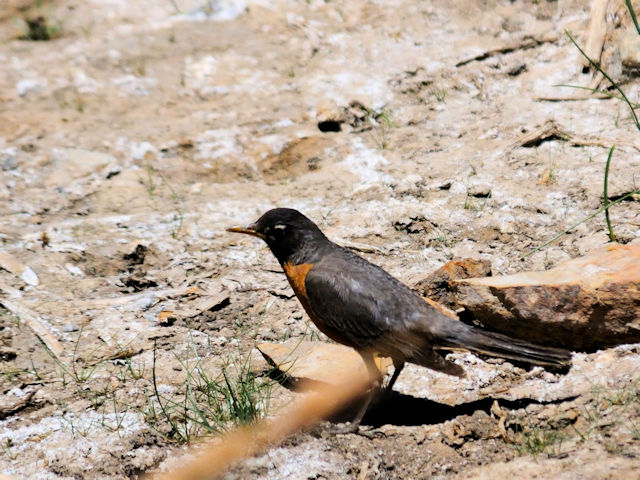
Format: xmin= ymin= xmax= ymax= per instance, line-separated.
xmin=228 ymin=208 xmax=571 ymax=431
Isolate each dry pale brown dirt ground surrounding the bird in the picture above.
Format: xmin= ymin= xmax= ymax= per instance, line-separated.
xmin=0 ymin=0 xmax=640 ymax=479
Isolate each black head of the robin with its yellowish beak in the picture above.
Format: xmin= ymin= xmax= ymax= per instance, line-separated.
xmin=228 ymin=208 xmax=327 ymax=264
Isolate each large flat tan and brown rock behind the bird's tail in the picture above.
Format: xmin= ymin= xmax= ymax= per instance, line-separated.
xmin=451 ymin=244 xmax=640 ymax=351
